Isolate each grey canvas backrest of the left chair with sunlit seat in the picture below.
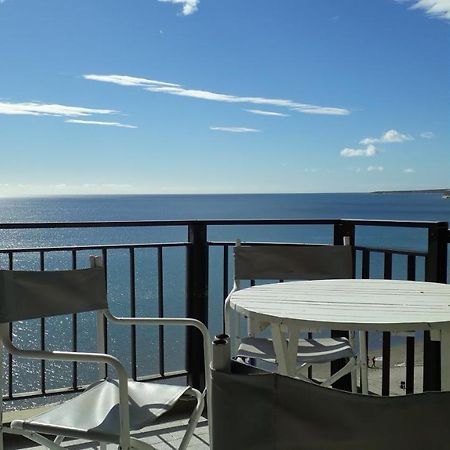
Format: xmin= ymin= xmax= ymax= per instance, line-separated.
xmin=0 ymin=268 xmax=108 ymax=323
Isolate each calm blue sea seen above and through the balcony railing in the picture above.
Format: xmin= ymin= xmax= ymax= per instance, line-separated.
xmin=0 ymin=194 xmax=450 ymax=402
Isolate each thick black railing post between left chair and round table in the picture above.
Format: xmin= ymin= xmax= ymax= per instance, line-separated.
xmin=186 ymin=222 xmax=208 ymax=389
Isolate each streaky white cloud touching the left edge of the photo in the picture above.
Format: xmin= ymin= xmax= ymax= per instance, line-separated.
xmin=0 ymin=102 xmax=117 ymax=117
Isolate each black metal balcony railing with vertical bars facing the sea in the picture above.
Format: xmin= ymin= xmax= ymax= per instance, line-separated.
xmin=0 ymin=219 xmax=450 ymax=399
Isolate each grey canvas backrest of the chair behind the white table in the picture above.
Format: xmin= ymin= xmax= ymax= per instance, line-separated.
xmin=234 ymin=244 xmax=353 ymax=280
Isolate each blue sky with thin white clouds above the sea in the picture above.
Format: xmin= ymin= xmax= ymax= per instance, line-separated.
xmin=0 ymin=0 xmax=450 ymax=196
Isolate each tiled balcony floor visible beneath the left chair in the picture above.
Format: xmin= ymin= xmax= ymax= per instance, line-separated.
xmin=4 ymin=417 xmax=209 ymax=450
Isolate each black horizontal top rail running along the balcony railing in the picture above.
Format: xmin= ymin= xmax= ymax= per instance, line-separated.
xmin=0 ymin=219 xmax=448 ymax=230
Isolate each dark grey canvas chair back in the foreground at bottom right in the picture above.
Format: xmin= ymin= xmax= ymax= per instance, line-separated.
xmin=212 ymin=362 xmax=450 ymax=450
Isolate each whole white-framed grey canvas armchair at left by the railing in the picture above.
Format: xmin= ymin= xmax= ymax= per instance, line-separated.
xmin=0 ymin=258 xmax=210 ymax=450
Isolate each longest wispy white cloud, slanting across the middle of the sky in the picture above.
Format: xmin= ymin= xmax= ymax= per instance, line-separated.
xmin=84 ymin=74 xmax=350 ymax=116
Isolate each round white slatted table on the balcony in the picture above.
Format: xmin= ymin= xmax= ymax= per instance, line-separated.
xmin=230 ymin=280 xmax=450 ymax=390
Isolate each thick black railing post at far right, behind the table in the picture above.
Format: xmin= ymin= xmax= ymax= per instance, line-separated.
xmin=423 ymin=222 xmax=448 ymax=391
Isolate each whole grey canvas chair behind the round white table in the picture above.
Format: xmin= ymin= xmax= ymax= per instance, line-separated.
xmin=225 ymin=241 xmax=357 ymax=391
